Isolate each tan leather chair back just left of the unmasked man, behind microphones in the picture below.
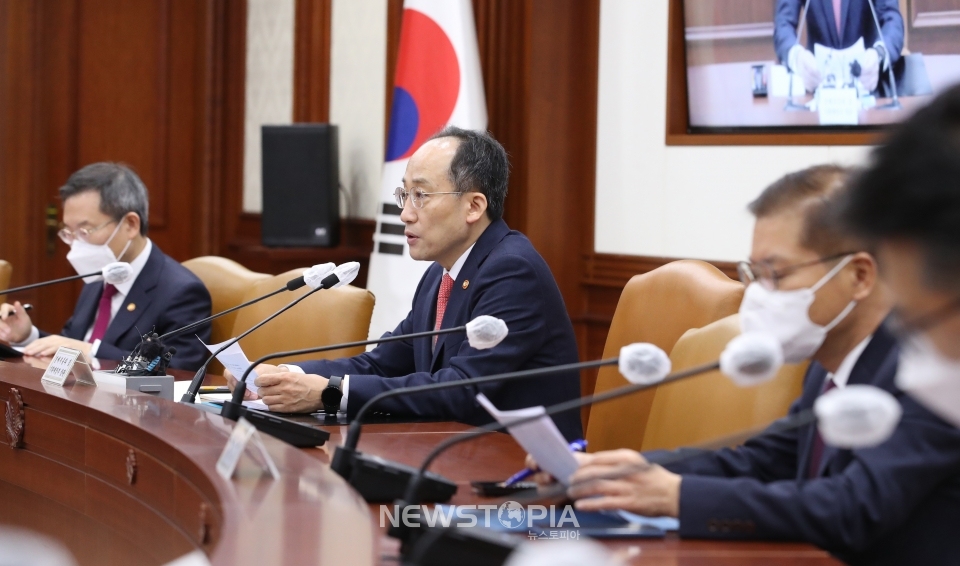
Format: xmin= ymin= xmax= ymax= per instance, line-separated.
xmin=233 ymin=269 xmax=374 ymax=364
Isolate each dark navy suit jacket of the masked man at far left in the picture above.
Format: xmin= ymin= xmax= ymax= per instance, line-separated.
xmin=48 ymin=243 xmax=211 ymax=370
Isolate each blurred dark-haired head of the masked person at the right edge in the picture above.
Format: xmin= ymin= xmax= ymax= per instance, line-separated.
xmin=843 ymin=86 xmax=960 ymax=427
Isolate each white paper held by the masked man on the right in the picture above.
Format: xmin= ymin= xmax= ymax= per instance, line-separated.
xmin=477 ymin=393 xmax=578 ymax=485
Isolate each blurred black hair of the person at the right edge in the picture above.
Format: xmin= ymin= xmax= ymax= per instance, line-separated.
xmin=839 ymin=86 xmax=960 ymax=290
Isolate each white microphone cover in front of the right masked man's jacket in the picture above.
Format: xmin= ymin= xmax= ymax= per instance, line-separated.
xmin=813 ymin=384 xmax=903 ymax=448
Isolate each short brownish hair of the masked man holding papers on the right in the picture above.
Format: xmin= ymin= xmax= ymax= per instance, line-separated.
xmin=747 ymin=164 xmax=863 ymax=256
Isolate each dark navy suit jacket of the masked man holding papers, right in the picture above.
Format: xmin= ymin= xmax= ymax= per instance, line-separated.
xmin=649 ymin=327 xmax=960 ymax=565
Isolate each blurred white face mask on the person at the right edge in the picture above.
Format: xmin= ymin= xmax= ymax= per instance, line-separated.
xmin=896 ymin=335 xmax=960 ymax=427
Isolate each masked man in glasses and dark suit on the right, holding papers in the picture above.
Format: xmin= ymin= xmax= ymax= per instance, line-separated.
xmin=540 ymin=166 xmax=960 ymax=564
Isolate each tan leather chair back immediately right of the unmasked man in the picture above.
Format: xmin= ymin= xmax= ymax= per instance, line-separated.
xmin=587 ymin=260 xmax=743 ymax=452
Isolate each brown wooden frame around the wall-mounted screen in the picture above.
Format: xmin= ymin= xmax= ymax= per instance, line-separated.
xmin=666 ymin=0 xmax=883 ymax=145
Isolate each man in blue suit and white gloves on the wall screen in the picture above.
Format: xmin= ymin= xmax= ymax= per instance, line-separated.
xmin=773 ymin=0 xmax=903 ymax=92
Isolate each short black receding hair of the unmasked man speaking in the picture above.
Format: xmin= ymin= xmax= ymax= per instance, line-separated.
xmin=430 ymin=126 xmax=510 ymax=220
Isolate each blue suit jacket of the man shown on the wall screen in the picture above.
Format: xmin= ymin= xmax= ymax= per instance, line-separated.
xmin=773 ymin=0 xmax=903 ymax=95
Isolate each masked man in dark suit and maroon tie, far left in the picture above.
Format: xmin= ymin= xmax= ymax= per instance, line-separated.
xmin=0 ymin=163 xmax=211 ymax=369
